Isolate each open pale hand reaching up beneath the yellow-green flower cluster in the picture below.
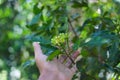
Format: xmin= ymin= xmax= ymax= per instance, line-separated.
xmin=33 ymin=42 xmax=78 ymax=80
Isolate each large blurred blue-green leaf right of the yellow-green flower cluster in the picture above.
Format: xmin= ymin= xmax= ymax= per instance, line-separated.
xmin=82 ymin=31 xmax=115 ymax=47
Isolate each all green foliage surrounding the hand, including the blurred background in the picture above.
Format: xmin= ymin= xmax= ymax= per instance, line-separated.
xmin=0 ymin=0 xmax=120 ymax=80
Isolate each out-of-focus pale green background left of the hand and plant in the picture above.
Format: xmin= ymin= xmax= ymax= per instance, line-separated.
xmin=0 ymin=0 xmax=39 ymax=80
